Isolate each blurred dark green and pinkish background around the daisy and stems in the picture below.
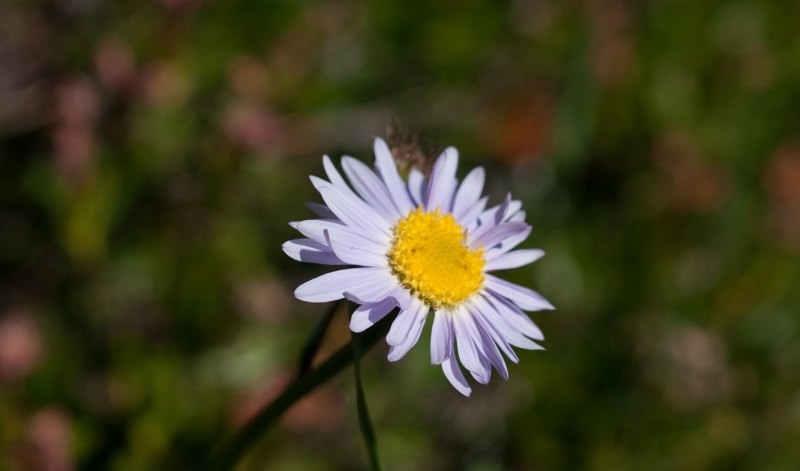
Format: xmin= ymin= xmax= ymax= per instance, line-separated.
xmin=0 ymin=0 xmax=800 ymax=471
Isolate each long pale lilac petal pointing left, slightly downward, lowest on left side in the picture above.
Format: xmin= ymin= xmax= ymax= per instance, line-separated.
xmin=294 ymin=267 xmax=386 ymax=303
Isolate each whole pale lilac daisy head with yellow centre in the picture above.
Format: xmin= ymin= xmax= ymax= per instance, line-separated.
xmin=283 ymin=139 xmax=553 ymax=396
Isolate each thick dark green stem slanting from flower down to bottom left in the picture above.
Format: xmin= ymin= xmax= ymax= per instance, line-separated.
xmin=207 ymin=316 xmax=394 ymax=471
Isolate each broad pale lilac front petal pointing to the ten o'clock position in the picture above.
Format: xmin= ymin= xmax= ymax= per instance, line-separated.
xmin=317 ymin=185 xmax=392 ymax=244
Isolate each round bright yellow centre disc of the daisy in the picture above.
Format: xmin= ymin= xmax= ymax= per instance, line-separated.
xmin=388 ymin=208 xmax=486 ymax=308
